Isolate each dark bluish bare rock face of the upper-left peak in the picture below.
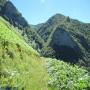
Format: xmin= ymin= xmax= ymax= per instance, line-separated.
xmin=1 ymin=1 xmax=28 ymax=28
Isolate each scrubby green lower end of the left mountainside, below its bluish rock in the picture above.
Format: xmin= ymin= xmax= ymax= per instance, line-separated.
xmin=22 ymin=26 xmax=44 ymax=52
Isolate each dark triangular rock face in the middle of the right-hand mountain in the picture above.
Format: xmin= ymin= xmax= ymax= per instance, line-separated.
xmin=51 ymin=28 xmax=80 ymax=63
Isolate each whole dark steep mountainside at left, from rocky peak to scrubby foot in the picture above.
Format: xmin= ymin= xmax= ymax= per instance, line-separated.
xmin=0 ymin=0 xmax=43 ymax=51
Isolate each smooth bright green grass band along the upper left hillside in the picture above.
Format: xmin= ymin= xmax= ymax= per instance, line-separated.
xmin=0 ymin=18 xmax=38 ymax=54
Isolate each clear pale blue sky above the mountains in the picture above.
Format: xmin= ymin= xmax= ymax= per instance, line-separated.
xmin=11 ymin=0 xmax=90 ymax=25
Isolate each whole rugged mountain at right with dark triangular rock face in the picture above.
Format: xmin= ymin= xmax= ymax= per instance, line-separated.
xmin=37 ymin=14 xmax=90 ymax=70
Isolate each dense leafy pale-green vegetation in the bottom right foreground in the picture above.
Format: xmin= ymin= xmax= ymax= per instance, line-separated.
xmin=46 ymin=59 xmax=90 ymax=90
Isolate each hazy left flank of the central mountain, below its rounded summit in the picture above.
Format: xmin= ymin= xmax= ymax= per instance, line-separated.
xmin=37 ymin=14 xmax=65 ymax=41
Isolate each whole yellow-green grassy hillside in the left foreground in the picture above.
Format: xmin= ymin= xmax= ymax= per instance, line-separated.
xmin=0 ymin=17 xmax=48 ymax=90
